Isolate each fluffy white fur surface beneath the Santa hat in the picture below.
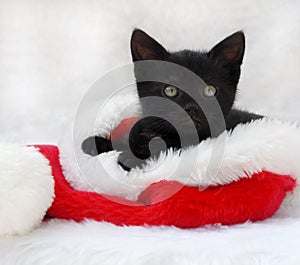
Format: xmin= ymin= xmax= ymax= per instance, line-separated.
xmin=0 ymin=218 xmax=300 ymax=265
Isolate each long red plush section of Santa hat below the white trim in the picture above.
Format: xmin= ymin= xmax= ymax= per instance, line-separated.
xmin=36 ymin=145 xmax=296 ymax=228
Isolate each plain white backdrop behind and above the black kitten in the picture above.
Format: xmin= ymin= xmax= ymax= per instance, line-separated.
xmin=0 ymin=0 xmax=300 ymax=143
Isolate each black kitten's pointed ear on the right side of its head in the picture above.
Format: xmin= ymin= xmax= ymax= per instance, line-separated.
xmin=208 ymin=31 xmax=245 ymax=66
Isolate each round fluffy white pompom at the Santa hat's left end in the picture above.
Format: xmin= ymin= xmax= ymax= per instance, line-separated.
xmin=0 ymin=143 xmax=54 ymax=236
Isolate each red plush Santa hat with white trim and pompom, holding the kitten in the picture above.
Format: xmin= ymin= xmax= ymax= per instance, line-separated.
xmin=0 ymin=91 xmax=300 ymax=235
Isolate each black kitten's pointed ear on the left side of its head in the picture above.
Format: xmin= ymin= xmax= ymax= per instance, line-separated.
xmin=130 ymin=29 xmax=169 ymax=62
